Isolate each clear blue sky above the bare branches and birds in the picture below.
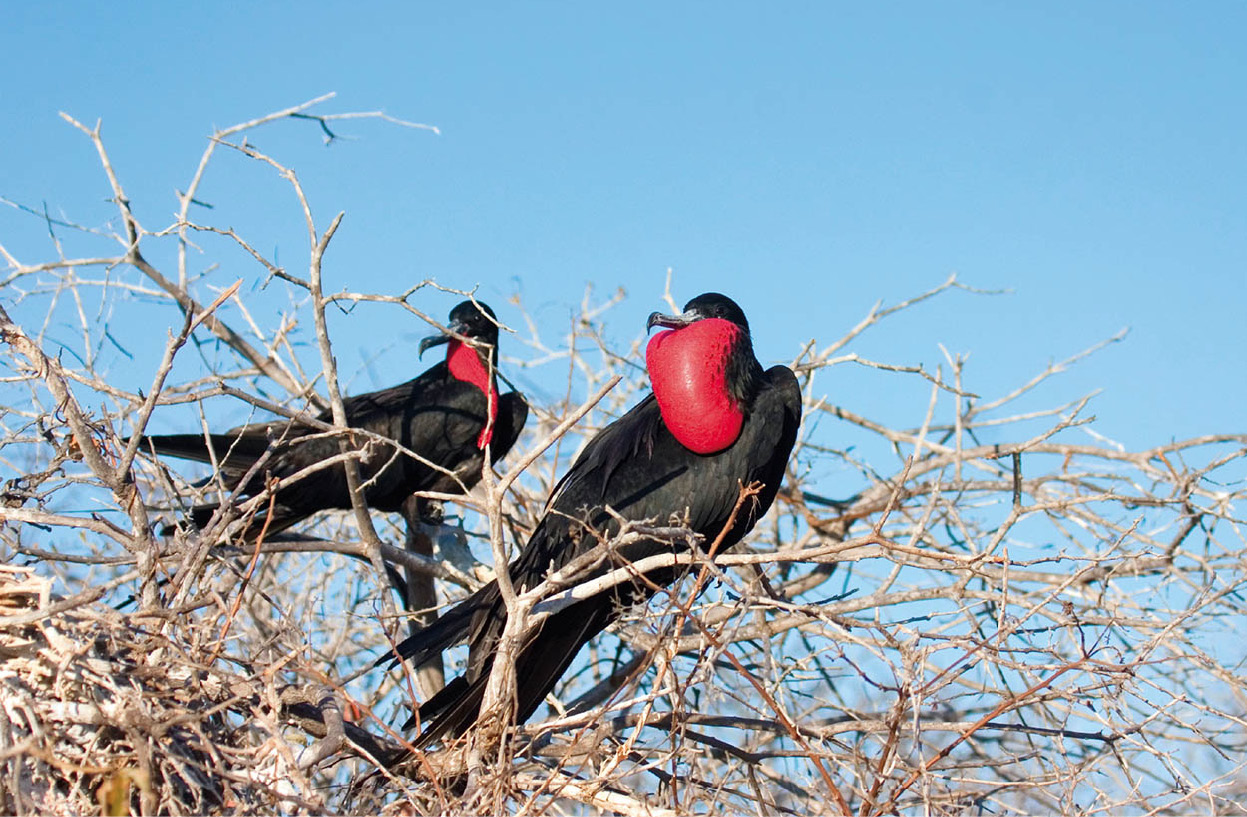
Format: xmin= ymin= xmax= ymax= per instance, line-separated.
xmin=0 ymin=1 xmax=1247 ymax=448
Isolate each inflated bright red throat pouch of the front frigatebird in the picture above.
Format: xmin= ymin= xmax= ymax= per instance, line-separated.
xmin=645 ymin=318 xmax=761 ymax=454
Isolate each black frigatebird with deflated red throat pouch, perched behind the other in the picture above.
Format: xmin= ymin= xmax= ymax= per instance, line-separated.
xmin=139 ymin=301 xmax=529 ymax=539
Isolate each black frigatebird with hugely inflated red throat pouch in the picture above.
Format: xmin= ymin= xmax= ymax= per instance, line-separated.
xmin=378 ymin=293 xmax=801 ymax=747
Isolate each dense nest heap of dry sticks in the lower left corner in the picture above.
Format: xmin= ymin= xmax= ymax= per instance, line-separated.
xmin=0 ymin=565 xmax=369 ymax=815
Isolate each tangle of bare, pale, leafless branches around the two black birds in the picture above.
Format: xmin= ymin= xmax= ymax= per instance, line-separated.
xmin=0 ymin=97 xmax=1247 ymax=815
